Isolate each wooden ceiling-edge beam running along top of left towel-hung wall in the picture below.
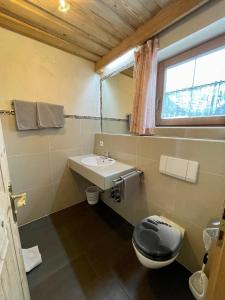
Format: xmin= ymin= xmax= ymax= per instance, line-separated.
xmin=0 ymin=12 xmax=100 ymax=62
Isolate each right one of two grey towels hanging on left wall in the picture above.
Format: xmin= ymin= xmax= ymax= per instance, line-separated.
xmin=37 ymin=102 xmax=64 ymax=128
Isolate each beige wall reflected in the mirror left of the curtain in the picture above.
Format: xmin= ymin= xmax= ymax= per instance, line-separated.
xmin=102 ymin=74 xmax=133 ymax=119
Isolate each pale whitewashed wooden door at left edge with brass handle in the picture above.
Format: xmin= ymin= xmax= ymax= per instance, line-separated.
xmin=0 ymin=118 xmax=30 ymax=300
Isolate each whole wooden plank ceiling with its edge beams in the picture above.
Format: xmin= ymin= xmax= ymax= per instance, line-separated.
xmin=0 ymin=0 xmax=211 ymax=71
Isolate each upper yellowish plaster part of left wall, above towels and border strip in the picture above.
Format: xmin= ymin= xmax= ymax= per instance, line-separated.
xmin=0 ymin=28 xmax=100 ymax=116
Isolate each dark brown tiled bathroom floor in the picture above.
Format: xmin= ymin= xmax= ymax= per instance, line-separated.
xmin=20 ymin=203 xmax=193 ymax=300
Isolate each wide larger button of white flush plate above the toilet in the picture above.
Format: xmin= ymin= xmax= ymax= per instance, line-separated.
xmin=166 ymin=156 xmax=188 ymax=180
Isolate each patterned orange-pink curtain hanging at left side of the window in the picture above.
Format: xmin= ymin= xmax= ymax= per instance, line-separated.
xmin=131 ymin=38 xmax=159 ymax=135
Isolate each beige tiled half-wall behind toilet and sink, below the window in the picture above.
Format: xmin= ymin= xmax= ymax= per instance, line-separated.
xmin=95 ymin=134 xmax=225 ymax=271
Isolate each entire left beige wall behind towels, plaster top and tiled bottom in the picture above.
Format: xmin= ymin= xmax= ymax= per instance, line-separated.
xmin=0 ymin=28 xmax=100 ymax=224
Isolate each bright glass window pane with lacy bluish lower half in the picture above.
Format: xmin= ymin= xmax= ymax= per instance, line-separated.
xmin=161 ymin=49 xmax=225 ymax=119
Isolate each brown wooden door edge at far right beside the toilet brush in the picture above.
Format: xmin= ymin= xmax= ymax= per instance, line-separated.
xmin=206 ymin=209 xmax=225 ymax=300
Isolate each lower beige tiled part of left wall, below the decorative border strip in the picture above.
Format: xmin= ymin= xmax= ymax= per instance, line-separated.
xmin=1 ymin=116 xmax=100 ymax=225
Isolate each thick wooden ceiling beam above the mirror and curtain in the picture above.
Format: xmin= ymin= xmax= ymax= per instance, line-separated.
xmin=96 ymin=0 xmax=211 ymax=72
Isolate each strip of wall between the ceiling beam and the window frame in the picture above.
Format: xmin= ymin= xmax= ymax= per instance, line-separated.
xmin=158 ymin=0 xmax=225 ymax=60
